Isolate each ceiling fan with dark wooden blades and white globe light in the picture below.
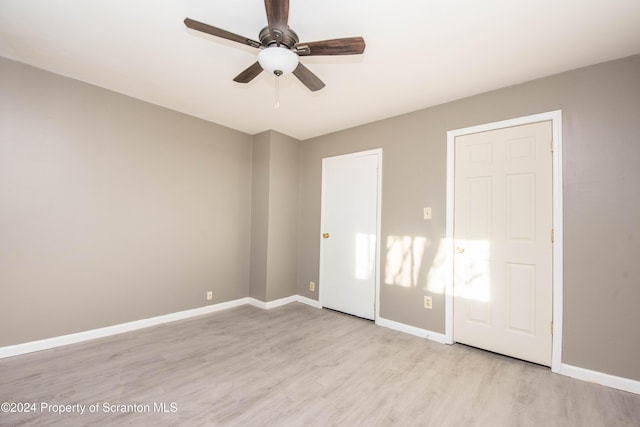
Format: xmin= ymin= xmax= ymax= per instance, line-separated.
xmin=184 ymin=0 xmax=365 ymax=91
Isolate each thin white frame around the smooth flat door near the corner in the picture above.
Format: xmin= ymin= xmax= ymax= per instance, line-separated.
xmin=318 ymin=148 xmax=382 ymax=320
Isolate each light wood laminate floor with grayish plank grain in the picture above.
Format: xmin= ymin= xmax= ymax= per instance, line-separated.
xmin=0 ymin=303 xmax=640 ymax=427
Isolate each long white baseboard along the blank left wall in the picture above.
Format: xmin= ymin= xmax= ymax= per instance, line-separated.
xmin=0 ymin=298 xmax=249 ymax=359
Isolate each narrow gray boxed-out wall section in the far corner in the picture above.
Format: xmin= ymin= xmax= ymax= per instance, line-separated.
xmin=250 ymin=131 xmax=300 ymax=301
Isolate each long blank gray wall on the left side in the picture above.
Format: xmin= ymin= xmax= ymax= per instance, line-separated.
xmin=0 ymin=58 xmax=251 ymax=346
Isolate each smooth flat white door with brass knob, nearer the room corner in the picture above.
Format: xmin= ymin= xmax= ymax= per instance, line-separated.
xmin=320 ymin=152 xmax=380 ymax=320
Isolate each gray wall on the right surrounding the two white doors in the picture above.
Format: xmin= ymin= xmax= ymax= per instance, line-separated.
xmin=298 ymin=56 xmax=640 ymax=380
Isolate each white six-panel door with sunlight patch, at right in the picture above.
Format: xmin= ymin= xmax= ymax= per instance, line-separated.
xmin=453 ymin=121 xmax=553 ymax=366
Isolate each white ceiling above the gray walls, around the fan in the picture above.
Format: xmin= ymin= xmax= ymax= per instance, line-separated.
xmin=0 ymin=0 xmax=640 ymax=139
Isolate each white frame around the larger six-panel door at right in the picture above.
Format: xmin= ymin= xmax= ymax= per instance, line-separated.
xmin=444 ymin=110 xmax=563 ymax=372
